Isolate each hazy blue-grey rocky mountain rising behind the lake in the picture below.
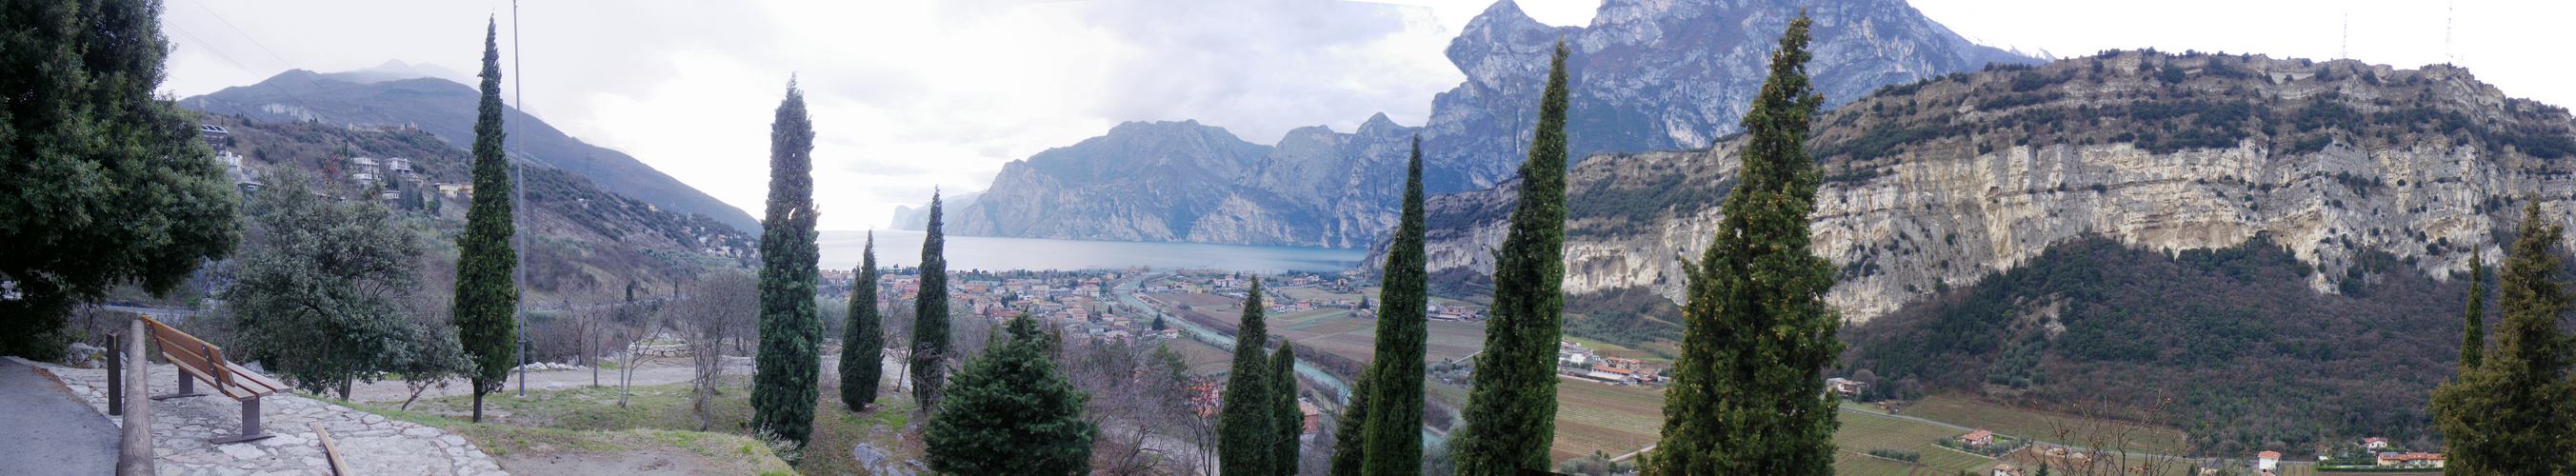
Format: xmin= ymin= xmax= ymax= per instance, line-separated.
xmin=950 ymin=0 xmax=2038 ymax=247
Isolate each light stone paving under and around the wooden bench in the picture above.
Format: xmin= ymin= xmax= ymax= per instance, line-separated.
xmin=33 ymin=363 xmax=502 ymax=476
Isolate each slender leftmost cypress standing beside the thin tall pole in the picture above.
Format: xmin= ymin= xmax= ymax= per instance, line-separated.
xmin=449 ymin=21 xmax=518 ymax=422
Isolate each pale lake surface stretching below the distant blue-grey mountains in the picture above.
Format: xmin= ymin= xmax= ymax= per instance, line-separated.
xmin=816 ymin=229 xmax=1368 ymax=272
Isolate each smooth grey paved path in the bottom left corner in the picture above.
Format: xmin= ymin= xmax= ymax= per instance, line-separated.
xmin=0 ymin=358 xmax=118 ymax=473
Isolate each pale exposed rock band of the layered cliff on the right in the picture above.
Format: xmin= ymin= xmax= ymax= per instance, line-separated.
xmin=1370 ymin=51 xmax=2576 ymax=322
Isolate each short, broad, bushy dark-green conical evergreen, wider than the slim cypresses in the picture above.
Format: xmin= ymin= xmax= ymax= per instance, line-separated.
xmin=922 ymin=314 xmax=1100 ymax=476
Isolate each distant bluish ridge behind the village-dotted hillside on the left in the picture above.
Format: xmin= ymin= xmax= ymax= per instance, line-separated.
xmin=180 ymin=62 xmax=760 ymax=229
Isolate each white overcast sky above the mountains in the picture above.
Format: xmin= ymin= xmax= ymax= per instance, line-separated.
xmin=162 ymin=0 xmax=2576 ymax=229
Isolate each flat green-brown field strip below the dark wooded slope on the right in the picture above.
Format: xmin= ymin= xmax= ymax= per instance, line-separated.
xmin=1899 ymin=396 xmax=2185 ymax=455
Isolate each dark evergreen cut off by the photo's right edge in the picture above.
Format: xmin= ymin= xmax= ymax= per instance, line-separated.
xmin=2432 ymin=198 xmax=2576 ymax=476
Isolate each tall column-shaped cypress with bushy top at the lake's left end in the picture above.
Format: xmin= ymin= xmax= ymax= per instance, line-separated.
xmin=752 ymin=80 xmax=822 ymax=446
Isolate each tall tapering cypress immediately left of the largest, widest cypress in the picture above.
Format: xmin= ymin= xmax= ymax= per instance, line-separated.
xmin=1452 ymin=39 xmax=1568 ymax=476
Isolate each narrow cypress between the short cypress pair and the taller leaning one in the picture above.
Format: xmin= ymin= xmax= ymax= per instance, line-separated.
xmin=1366 ymin=136 xmax=1429 ymax=476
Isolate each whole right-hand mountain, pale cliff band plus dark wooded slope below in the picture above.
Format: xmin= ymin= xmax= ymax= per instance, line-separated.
xmin=1368 ymin=51 xmax=2576 ymax=453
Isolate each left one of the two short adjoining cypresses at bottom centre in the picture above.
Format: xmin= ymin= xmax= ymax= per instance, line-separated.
xmin=1216 ymin=278 xmax=1278 ymax=476
